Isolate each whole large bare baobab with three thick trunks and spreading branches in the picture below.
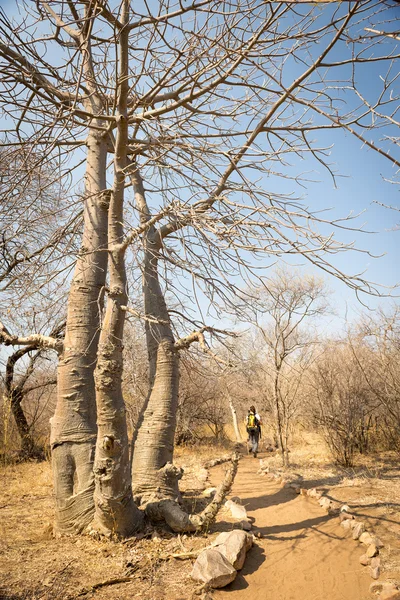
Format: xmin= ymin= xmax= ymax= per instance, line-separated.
xmin=0 ymin=0 xmax=400 ymax=535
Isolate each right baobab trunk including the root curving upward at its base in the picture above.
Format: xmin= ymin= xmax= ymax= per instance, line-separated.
xmin=131 ymin=170 xmax=238 ymax=532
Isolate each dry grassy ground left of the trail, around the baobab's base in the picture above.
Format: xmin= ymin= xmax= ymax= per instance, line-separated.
xmin=0 ymin=444 xmax=230 ymax=600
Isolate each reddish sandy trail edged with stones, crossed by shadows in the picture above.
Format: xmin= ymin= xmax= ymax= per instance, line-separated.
xmin=213 ymin=456 xmax=372 ymax=600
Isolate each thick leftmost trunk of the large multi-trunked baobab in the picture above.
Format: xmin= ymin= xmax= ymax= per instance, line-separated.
xmin=50 ymin=133 xmax=109 ymax=533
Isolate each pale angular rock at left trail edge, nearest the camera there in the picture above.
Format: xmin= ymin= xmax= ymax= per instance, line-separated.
xmin=190 ymin=548 xmax=237 ymax=588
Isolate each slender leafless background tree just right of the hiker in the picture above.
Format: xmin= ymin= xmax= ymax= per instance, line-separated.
xmin=244 ymin=269 xmax=328 ymax=465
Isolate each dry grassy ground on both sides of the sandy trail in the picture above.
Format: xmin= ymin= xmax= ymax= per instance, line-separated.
xmin=0 ymin=433 xmax=400 ymax=600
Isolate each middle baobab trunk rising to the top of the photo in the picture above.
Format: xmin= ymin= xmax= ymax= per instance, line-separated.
xmin=92 ymin=0 xmax=142 ymax=537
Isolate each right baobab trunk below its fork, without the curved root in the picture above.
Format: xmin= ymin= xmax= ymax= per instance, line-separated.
xmin=132 ymin=244 xmax=181 ymax=503
